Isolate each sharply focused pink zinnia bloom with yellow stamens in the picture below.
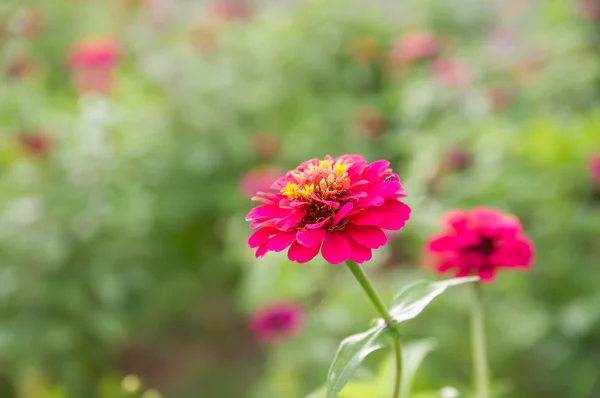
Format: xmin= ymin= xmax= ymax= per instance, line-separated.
xmin=246 ymin=155 xmax=410 ymax=264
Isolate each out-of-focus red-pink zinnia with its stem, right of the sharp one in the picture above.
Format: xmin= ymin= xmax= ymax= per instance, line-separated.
xmin=425 ymin=207 xmax=534 ymax=398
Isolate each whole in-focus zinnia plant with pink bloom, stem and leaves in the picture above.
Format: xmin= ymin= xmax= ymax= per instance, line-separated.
xmin=246 ymin=155 xmax=475 ymax=398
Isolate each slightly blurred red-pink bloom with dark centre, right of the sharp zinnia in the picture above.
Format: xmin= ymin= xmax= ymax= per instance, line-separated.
xmin=425 ymin=207 xmax=534 ymax=282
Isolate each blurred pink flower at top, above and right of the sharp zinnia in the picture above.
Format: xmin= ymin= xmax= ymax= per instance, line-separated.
xmin=391 ymin=30 xmax=439 ymax=63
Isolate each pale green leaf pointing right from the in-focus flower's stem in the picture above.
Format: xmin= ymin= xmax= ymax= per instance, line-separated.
xmin=390 ymin=276 xmax=479 ymax=323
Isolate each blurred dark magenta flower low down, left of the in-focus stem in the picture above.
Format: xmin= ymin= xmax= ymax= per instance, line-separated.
xmin=249 ymin=302 xmax=304 ymax=344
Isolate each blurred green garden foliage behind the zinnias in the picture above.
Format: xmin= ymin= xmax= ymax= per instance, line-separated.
xmin=0 ymin=0 xmax=600 ymax=398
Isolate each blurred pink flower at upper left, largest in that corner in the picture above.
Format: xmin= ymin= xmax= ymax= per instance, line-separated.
xmin=68 ymin=38 xmax=120 ymax=94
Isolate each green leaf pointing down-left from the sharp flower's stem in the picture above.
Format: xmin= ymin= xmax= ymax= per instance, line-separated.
xmin=325 ymin=323 xmax=386 ymax=398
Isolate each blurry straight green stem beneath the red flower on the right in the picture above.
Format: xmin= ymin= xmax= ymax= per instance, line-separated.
xmin=471 ymin=282 xmax=490 ymax=398
